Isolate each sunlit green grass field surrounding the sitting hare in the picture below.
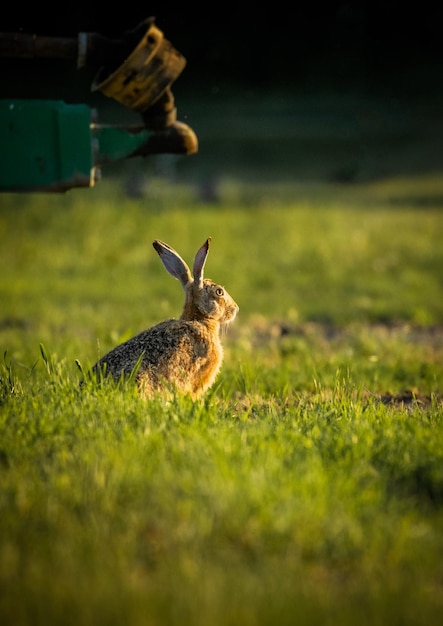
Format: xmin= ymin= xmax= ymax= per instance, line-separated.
xmin=0 ymin=178 xmax=443 ymax=626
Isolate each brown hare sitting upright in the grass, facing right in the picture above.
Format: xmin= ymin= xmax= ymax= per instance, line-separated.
xmin=92 ymin=238 xmax=239 ymax=399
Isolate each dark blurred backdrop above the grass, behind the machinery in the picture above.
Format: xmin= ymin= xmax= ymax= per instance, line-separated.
xmin=0 ymin=0 xmax=443 ymax=188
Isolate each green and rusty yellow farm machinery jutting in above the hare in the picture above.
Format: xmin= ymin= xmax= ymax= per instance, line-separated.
xmin=0 ymin=18 xmax=198 ymax=192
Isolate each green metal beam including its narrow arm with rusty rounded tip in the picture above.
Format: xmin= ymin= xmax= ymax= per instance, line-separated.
xmin=0 ymin=100 xmax=197 ymax=192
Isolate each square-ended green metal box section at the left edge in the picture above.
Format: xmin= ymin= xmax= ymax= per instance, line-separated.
xmin=0 ymin=100 xmax=94 ymax=191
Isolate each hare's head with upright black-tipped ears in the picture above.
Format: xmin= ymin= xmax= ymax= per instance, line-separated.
xmin=152 ymin=238 xmax=238 ymax=324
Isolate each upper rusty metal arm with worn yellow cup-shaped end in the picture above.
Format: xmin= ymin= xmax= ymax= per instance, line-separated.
xmin=0 ymin=17 xmax=195 ymax=130
